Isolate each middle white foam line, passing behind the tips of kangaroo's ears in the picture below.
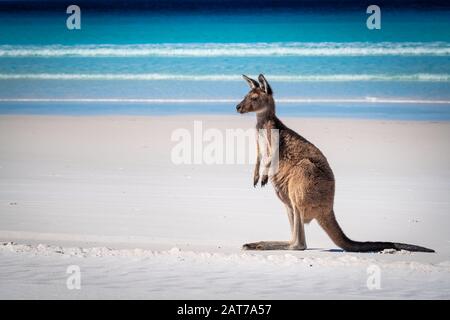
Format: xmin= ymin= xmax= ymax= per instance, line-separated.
xmin=0 ymin=73 xmax=450 ymax=82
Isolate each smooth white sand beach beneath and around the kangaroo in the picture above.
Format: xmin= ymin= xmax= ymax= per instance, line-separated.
xmin=0 ymin=115 xmax=450 ymax=299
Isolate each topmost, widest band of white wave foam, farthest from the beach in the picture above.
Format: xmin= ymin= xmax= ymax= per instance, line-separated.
xmin=0 ymin=42 xmax=450 ymax=57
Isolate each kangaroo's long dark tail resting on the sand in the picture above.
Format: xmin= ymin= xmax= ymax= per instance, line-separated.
xmin=318 ymin=211 xmax=434 ymax=252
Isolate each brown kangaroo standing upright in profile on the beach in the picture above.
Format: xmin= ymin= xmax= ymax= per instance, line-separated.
xmin=236 ymin=74 xmax=434 ymax=252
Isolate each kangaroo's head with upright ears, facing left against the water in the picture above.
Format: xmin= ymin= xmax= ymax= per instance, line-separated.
xmin=236 ymin=74 xmax=275 ymax=113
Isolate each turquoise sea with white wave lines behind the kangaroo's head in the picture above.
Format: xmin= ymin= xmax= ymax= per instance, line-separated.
xmin=0 ymin=9 xmax=450 ymax=120
